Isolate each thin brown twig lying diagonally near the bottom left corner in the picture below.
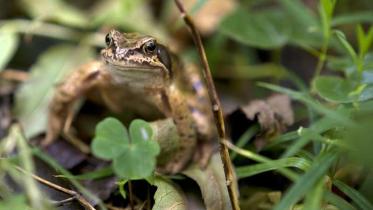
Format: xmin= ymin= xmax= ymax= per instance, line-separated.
xmin=16 ymin=166 xmax=96 ymax=210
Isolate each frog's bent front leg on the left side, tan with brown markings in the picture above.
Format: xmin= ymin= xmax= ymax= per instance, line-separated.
xmin=41 ymin=61 xmax=109 ymax=148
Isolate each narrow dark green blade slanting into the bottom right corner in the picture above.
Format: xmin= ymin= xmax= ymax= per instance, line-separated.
xmin=333 ymin=180 xmax=373 ymax=209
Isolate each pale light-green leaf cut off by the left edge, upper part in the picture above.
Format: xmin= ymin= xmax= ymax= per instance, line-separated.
xmin=0 ymin=27 xmax=18 ymax=72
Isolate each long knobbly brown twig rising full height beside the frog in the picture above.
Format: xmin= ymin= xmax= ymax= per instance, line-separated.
xmin=175 ymin=0 xmax=240 ymax=210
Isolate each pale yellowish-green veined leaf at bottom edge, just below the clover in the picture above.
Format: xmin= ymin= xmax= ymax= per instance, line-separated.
xmin=152 ymin=177 xmax=188 ymax=210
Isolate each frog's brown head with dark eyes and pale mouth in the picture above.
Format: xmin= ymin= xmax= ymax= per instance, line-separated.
xmin=101 ymin=30 xmax=172 ymax=88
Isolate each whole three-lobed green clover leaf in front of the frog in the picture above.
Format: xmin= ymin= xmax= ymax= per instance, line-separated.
xmin=92 ymin=117 xmax=160 ymax=180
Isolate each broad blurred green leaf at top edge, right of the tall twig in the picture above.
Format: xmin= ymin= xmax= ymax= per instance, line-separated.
xmin=220 ymin=0 xmax=320 ymax=49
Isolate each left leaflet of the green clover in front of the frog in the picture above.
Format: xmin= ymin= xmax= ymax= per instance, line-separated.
xmin=92 ymin=117 xmax=129 ymax=160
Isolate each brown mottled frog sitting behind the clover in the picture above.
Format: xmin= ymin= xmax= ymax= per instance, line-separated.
xmin=41 ymin=29 xmax=217 ymax=174
